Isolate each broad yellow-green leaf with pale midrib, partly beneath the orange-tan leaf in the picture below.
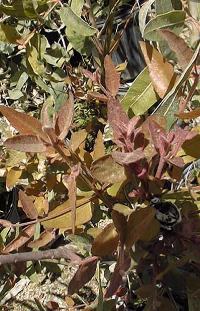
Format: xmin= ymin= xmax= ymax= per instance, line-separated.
xmin=121 ymin=67 xmax=157 ymax=115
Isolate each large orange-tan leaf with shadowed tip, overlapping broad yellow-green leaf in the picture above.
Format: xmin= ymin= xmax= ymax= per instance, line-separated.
xmin=140 ymin=42 xmax=176 ymax=98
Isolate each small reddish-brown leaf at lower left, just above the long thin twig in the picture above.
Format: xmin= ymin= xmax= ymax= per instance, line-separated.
xmin=19 ymin=190 xmax=38 ymax=219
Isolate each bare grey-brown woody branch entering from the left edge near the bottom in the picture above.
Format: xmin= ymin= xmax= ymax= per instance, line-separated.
xmin=0 ymin=246 xmax=81 ymax=265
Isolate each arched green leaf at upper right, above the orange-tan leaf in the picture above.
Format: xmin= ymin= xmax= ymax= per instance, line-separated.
xmin=144 ymin=10 xmax=186 ymax=41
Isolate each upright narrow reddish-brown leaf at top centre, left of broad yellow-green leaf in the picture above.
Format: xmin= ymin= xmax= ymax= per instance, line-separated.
xmin=104 ymin=55 xmax=120 ymax=97
